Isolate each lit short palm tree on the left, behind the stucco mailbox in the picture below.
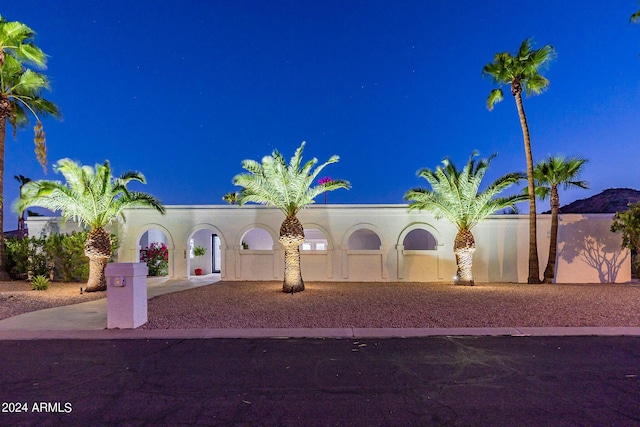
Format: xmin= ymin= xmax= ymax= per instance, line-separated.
xmin=15 ymin=159 xmax=164 ymax=292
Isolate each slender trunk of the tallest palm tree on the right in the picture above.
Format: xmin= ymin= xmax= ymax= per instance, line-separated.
xmin=511 ymin=89 xmax=540 ymax=283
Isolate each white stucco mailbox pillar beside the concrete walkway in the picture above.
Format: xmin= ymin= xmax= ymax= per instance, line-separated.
xmin=105 ymin=262 xmax=148 ymax=329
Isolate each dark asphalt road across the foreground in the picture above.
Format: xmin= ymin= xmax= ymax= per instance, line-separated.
xmin=0 ymin=337 xmax=640 ymax=426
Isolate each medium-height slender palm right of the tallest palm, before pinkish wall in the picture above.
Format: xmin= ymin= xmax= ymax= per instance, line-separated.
xmin=533 ymin=156 xmax=589 ymax=283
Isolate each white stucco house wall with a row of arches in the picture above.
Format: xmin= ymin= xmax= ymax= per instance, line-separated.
xmin=28 ymin=205 xmax=631 ymax=283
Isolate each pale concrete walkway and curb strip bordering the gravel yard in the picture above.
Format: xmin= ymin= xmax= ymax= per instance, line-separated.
xmin=0 ymin=276 xmax=640 ymax=340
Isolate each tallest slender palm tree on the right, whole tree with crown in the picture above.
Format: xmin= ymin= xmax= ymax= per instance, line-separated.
xmin=482 ymin=39 xmax=554 ymax=283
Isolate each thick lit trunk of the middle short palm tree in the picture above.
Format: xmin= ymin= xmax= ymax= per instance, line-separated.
xmin=279 ymin=215 xmax=304 ymax=293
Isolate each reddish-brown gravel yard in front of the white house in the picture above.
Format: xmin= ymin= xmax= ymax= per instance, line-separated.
xmin=0 ymin=282 xmax=640 ymax=329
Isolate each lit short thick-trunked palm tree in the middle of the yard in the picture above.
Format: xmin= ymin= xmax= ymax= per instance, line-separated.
xmin=233 ymin=142 xmax=350 ymax=293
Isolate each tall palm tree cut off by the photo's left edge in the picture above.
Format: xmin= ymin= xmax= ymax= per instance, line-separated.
xmin=0 ymin=16 xmax=60 ymax=280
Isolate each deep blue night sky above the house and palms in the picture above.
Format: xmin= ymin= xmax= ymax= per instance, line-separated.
xmin=0 ymin=0 xmax=640 ymax=229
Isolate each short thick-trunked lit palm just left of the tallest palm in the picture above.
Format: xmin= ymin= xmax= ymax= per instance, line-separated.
xmin=404 ymin=151 xmax=528 ymax=285
